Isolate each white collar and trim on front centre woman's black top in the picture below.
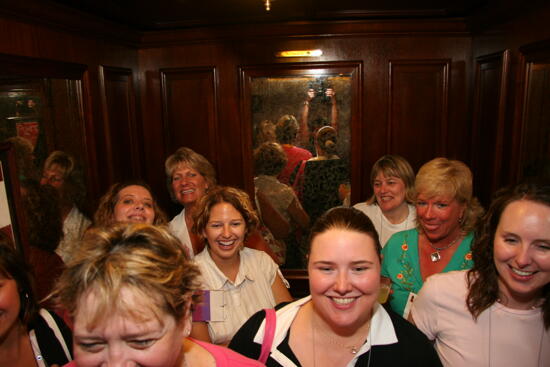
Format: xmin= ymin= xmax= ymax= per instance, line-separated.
xmin=254 ymin=296 xmax=398 ymax=367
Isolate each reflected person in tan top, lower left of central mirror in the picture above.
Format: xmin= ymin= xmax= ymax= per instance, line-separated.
xmin=254 ymin=143 xmax=309 ymax=267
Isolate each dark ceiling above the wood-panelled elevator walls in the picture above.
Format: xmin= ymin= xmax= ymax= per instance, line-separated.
xmin=44 ymin=0 xmax=492 ymax=31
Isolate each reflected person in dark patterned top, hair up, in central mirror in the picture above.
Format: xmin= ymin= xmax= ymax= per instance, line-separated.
xmin=291 ymin=126 xmax=349 ymax=221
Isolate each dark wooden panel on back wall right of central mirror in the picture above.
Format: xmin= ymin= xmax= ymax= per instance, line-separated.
xmin=387 ymin=60 xmax=450 ymax=168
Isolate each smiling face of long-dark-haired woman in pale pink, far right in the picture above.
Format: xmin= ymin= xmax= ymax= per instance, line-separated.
xmin=494 ymin=200 xmax=550 ymax=309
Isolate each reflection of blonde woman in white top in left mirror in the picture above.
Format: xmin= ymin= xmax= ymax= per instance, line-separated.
xmin=40 ymin=150 xmax=91 ymax=262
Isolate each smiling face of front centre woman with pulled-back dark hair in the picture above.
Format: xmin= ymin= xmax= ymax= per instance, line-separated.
xmin=308 ymin=228 xmax=380 ymax=331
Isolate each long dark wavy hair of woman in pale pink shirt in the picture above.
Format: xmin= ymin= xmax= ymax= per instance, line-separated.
xmin=466 ymin=183 xmax=550 ymax=329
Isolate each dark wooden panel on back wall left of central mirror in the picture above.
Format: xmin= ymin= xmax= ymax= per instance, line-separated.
xmin=161 ymin=67 xmax=219 ymax=165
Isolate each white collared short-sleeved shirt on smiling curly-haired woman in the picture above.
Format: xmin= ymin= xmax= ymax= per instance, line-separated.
xmin=194 ymin=247 xmax=279 ymax=344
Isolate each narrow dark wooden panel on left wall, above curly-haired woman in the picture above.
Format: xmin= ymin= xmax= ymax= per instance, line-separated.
xmin=100 ymin=65 xmax=141 ymax=183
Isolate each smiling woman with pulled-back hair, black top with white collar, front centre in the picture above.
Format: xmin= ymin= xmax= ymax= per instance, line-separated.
xmin=230 ymin=208 xmax=441 ymax=367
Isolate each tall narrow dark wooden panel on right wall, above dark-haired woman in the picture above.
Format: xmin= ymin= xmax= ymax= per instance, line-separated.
xmin=472 ymin=50 xmax=510 ymax=206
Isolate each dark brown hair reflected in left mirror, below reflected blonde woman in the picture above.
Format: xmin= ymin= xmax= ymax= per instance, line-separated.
xmin=21 ymin=179 xmax=63 ymax=252
